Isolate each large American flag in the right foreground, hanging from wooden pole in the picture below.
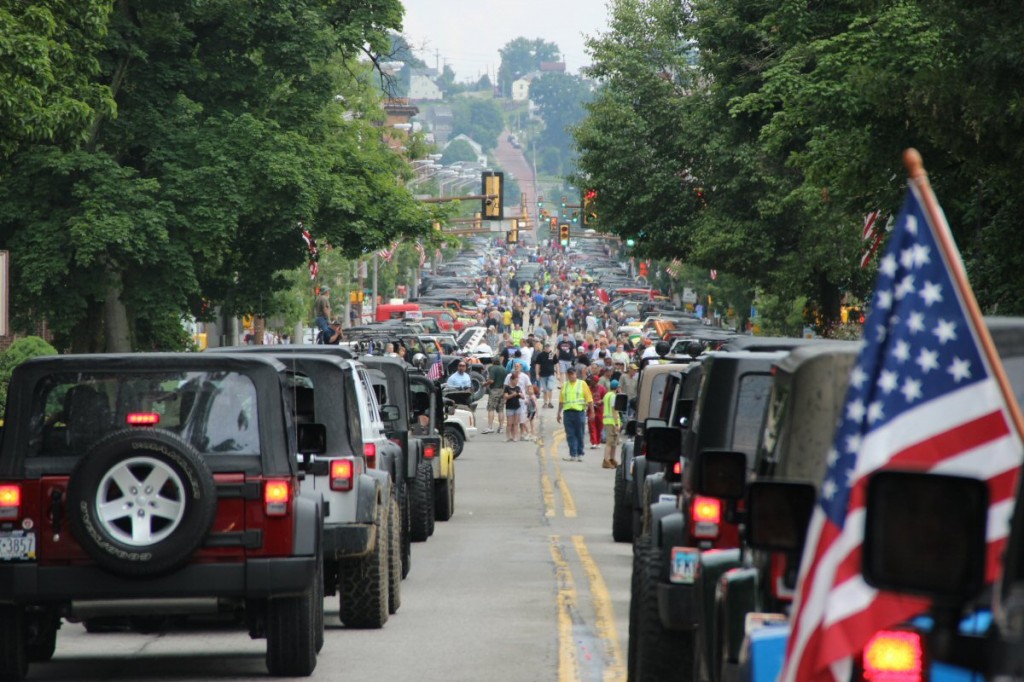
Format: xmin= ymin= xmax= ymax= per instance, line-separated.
xmin=781 ymin=182 xmax=1021 ymax=682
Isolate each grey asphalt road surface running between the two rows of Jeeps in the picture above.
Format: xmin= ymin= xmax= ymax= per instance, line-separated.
xmin=30 ymin=410 xmax=632 ymax=682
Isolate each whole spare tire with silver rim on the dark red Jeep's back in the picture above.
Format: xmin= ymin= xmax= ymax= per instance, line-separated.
xmin=68 ymin=429 xmax=217 ymax=577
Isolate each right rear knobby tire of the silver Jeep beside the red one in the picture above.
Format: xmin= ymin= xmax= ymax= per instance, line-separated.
xmin=338 ymin=505 xmax=389 ymax=630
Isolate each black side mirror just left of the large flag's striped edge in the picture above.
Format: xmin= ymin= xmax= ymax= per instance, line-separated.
xmin=746 ymin=480 xmax=817 ymax=554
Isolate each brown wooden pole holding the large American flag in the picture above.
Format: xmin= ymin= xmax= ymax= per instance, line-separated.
xmin=903 ymin=147 xmax=1024 ymax=438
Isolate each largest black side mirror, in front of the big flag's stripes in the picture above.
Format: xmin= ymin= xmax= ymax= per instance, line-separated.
xmin=862 ymin=471 xmax=988 ymax=604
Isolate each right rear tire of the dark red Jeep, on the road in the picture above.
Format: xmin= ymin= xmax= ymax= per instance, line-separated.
xmin=266 ymin=581 xmax=315 ymax=677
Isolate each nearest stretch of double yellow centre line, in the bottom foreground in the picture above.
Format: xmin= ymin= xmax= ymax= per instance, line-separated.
xmin=550 ymin=536 xmax=626 ymax=682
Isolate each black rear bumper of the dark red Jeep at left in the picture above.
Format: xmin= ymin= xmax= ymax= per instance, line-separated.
xmin=0 ymin=556 xmax=317 ymax=604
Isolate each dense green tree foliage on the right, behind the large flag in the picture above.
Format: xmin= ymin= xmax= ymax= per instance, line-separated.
xmin=573 ymin=0 xmax=1024 ymax=329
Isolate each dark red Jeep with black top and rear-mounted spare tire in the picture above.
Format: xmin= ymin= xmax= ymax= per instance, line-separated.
xmin=0 ymin=353 xmax=324 ymax=679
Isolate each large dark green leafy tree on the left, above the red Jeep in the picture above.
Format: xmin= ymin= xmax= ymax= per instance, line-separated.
xmin=0 ymin=0 xmax=429 ymax=350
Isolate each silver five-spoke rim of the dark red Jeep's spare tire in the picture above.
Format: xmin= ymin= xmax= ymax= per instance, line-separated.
xmin=96 ymin=457 xmax=185 ymax=547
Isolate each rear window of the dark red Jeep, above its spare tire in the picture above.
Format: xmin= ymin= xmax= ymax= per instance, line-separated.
xmin=27 ymin=372 xmax=260 ymax=457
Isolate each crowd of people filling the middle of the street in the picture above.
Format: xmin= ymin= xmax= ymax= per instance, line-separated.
xmin=466 ymin=238 xmax=655 ymax=468
